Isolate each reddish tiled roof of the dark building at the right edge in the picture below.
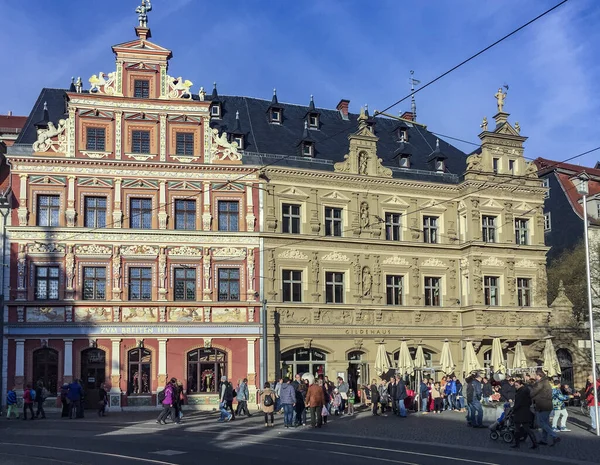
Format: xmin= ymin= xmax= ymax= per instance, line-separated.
xmin=534 ymin=158 xmax=600 ymax=225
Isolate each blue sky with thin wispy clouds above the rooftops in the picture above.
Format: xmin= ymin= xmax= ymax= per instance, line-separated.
xmin=0 ymin=0 xmax=600 ymax=165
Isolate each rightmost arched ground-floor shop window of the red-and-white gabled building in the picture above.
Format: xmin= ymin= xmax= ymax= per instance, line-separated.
xmin=187 ymin=349 xmax=227 ymax=394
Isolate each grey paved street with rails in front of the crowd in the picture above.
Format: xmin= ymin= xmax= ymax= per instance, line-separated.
xmin=0 ymin=404 xmax=600 ymax=465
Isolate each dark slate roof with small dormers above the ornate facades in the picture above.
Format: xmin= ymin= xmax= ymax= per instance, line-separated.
xmin=15 ymin=89 xmax=467 ymax=183
